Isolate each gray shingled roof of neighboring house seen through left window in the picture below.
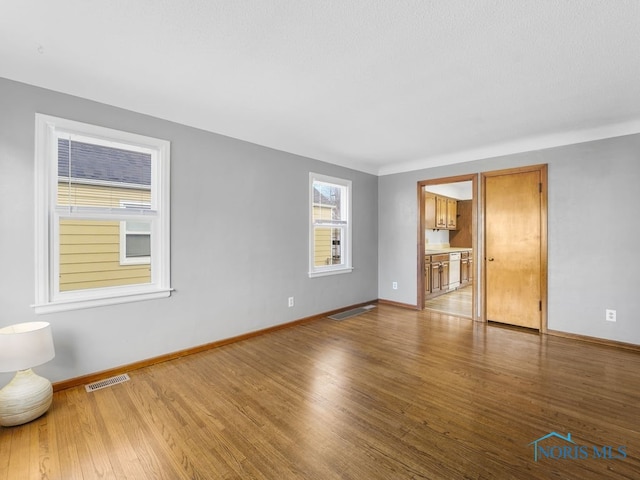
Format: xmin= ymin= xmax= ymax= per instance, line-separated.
xmin=58 ymin=139 xmax=151 ymax=186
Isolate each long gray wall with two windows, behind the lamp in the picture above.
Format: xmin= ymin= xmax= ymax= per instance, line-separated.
xmin=0 ymin=79 xmax=378 ymax=385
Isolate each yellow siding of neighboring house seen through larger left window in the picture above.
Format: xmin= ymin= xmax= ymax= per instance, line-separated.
xmin=58 ymin=183 xmax=151 ymax=292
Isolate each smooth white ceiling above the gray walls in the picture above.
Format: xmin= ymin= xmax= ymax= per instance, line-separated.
xmin=0 ymin=0 xmax=640 ymax=175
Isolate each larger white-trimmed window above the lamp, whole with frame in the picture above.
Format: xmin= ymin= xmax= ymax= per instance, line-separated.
xmin=34 ymin=114 xmax=171 ymax=313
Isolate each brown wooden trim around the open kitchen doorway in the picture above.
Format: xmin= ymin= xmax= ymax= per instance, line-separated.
xmin=417 ymin=173 xmax=480 ymax=321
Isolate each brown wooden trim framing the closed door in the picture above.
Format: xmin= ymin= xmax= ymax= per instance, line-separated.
xmin=477 ymin=164 xmax=548 ymax=333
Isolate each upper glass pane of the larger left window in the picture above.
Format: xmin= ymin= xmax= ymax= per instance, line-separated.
xmin=58 ymin=138 xmax=151 ymax=207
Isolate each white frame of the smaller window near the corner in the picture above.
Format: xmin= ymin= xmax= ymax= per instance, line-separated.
xmin=309 ymin=172 xmax=353 ymax=278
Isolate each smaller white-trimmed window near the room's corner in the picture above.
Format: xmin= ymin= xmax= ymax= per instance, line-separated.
xmin=309 ymin=173 xmax=353 ymax=277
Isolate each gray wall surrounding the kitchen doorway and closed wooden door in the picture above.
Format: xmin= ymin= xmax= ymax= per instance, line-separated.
xmin=378 ymin=135 xmax=640 ymax=344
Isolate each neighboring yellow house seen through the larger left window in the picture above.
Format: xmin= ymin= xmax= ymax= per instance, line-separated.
xmin=58 ymin=138 xmax=151 ymax=292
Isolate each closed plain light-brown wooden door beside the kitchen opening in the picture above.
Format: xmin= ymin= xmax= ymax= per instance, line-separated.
xmin=483 ymin=166 xmax=546 ymax=329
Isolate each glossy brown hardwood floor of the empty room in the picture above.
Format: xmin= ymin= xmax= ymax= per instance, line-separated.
xmin=0 ymin=305 xmax=640 ymax=480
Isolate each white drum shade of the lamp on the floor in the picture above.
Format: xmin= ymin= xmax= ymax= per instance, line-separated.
xmin=0 ymin=322 xmax=56 ymax=372
